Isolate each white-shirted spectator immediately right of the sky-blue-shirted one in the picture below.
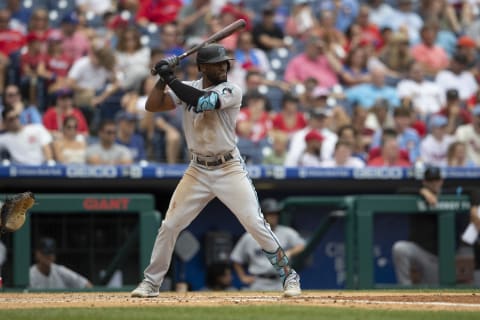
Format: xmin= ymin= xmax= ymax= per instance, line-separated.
xmin=397 ymin=63 xmax=445 ymax=119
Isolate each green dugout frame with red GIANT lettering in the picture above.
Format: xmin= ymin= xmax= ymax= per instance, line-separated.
xmin=13 ymin=194 xmax=161 ymax=287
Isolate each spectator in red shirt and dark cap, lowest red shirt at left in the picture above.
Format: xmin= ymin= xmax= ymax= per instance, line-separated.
xmin=43 ymin=88 xmax=89 ymax=139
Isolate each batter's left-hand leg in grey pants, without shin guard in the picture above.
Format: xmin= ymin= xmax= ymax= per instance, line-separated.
xmin=132 ymin=167 xmax=214 ymax=297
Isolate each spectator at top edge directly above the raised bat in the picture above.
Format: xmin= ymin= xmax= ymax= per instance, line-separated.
xmin=177 ymin=0 xmax=211 ymax=42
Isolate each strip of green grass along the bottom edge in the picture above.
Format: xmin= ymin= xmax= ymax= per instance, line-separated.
xmin=0 ymin=306 xmax=479 ymax=320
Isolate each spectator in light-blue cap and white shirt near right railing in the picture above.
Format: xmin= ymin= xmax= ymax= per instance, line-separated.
xmin=420 ymin=114 xmax=455 ymax=167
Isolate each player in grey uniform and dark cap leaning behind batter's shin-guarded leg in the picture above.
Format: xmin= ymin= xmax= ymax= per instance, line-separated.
xmin=230 ymin=198 xmax=305 ymax=291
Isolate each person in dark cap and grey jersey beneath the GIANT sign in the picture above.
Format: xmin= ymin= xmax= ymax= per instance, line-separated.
xmin=28 ymin=237 xmax=93 ymax=289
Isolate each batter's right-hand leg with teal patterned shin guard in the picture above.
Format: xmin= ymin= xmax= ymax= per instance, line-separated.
xmin=212 ymin=162 xmax=300 ymax=296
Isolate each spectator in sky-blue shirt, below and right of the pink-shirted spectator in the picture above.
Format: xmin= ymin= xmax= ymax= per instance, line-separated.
xmin=345 ymin=68 xmax=400 ymax=109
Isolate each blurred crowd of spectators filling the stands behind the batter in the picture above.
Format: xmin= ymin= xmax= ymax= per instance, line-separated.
xmin=0 ymin=0 xmax=480 ymax=168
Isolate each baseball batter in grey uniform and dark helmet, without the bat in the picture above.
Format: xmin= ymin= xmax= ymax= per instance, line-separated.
xmin=131 ymin=44 xmax=301 ymax=298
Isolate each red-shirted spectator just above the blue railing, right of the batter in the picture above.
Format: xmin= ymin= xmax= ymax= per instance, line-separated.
xmin=367 ymin=129 xmax=410 ymax=167
